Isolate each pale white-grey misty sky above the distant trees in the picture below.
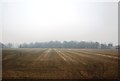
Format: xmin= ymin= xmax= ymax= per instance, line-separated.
xmin=0 ymin=0 xmax=118 ymax=44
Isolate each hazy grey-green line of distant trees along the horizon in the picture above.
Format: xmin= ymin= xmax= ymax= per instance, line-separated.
xmin=0 ymin=41 xmax=118 ymax=49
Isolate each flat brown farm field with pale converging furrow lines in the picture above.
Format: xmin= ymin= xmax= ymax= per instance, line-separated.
xmin=2 ymin=48 xmax=119 ymax=79
